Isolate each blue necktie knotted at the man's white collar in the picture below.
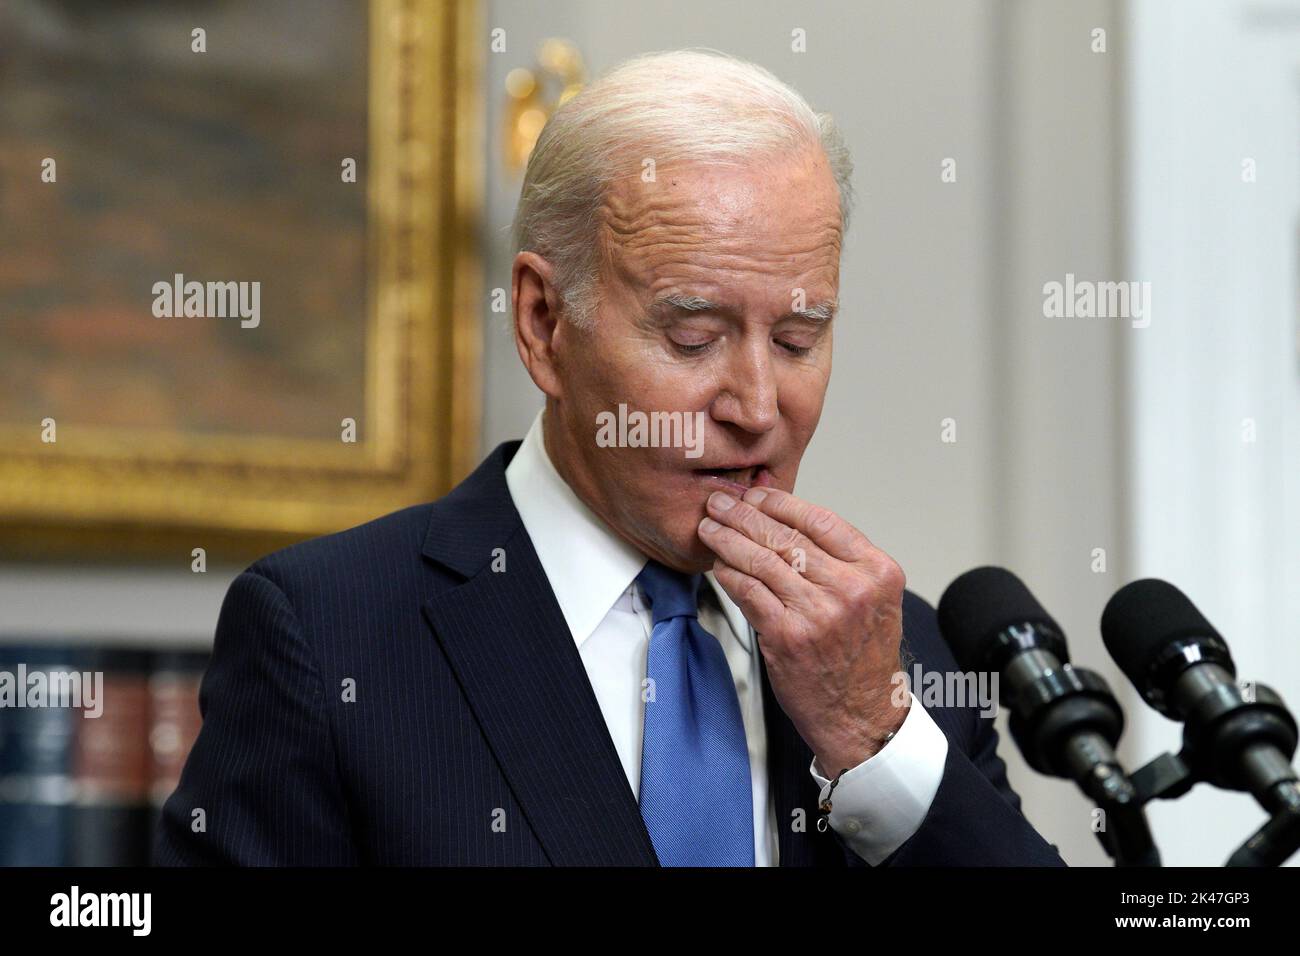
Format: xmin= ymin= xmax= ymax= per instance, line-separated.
xmin=637 ymin=561 xmax=754 ymax=866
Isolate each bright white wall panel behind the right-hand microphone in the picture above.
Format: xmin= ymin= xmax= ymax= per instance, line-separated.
xmin=1127 ymin=0 xmax=1300 ymax=865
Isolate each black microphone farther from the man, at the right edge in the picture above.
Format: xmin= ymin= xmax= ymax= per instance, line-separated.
xmin=1101 ymin=579 xmax=1300 ymax=813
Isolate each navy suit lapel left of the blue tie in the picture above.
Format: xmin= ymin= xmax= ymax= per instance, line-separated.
xmin=424 ymin=442 xmax=658 ymax=866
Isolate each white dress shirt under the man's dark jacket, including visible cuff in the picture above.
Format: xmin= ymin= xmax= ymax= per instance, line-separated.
xmin=506 ymin=412 xmax=948 ymax=866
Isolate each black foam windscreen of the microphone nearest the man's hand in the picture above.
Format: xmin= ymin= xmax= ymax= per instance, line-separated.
xmin=939 ymin=567 xmax=1061 ymax=671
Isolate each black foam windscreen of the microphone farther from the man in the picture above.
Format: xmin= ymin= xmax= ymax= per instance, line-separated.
xmin=1101 ymin=578 xmax=1223 ymax=688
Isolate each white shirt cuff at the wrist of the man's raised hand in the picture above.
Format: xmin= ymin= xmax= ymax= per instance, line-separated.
xmin=809 ymin=695 xmax=948 ymax=866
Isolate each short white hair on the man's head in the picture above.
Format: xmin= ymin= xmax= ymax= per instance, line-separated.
xmin=514 ymin=49 xmax=853 ymax=328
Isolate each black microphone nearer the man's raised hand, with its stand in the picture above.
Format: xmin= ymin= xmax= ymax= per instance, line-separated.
xmin=937 ymin=567 xmax=1160 ymax=866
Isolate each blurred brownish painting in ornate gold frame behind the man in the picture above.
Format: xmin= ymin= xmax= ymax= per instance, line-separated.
xmin=0 ymin=0 xmax=482 ymax=557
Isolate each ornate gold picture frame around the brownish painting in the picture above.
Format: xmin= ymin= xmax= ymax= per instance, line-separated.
xmin=0 ymin=0 xmax=482 ymax=561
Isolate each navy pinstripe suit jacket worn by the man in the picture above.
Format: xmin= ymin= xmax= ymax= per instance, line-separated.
xmin=155 ymin=442 xmax=1061 ymax=866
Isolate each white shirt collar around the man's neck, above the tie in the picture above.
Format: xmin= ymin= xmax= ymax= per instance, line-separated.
xmin=506 ymin=410 xmax=751 ymax=652
